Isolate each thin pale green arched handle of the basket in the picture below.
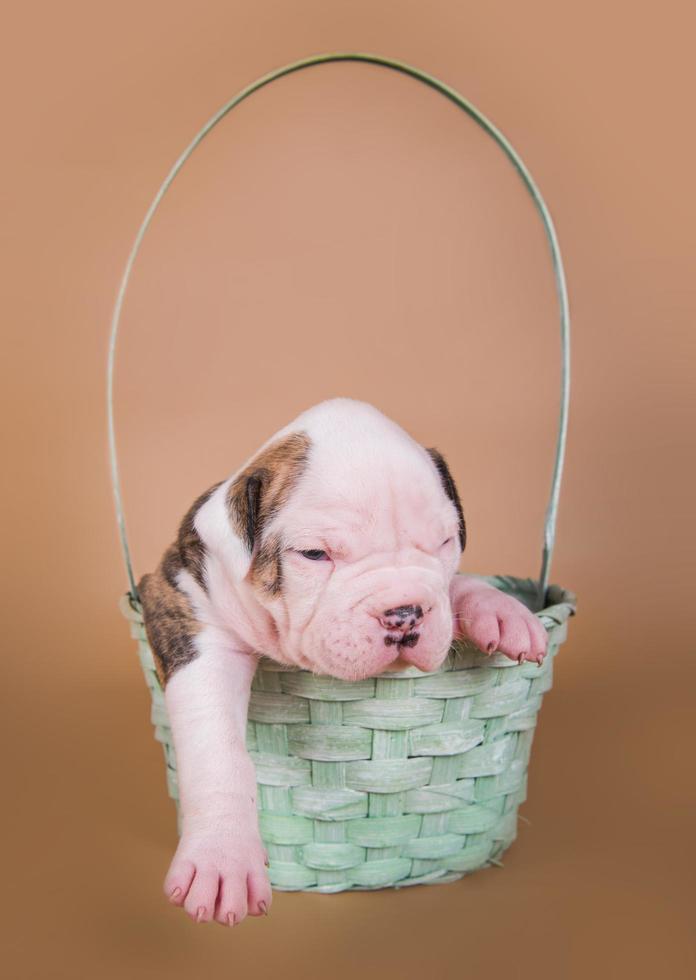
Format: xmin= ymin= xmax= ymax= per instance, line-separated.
xmin=107 ymin=52 xmax=570 ymax=609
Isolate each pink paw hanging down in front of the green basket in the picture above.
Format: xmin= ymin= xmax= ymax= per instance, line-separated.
xmin=164 ymin=827 xmax=272 ymax=926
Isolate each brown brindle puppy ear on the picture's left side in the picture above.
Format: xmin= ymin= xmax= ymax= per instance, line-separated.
xmin=227 ymin=432 xmax=311 ymax=574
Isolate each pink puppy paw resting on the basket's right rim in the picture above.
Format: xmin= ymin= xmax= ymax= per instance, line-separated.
xmin=451 ymin=576 xmax=548 ymax=664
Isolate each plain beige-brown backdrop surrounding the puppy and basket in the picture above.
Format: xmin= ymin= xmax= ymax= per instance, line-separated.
xmin=0 ymin=0 xmax=696 ymax=980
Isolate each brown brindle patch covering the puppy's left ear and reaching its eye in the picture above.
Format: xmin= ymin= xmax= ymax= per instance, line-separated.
xmin=227 ymin=432 xmax=311 ymax=595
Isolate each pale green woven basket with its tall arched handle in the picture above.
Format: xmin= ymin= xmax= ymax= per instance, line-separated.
xmin=107 ymin=53 xmax=575 ymax=892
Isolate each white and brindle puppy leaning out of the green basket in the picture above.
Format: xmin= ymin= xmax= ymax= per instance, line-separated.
xmin=138 ymin=398 xmax=546 ymax=925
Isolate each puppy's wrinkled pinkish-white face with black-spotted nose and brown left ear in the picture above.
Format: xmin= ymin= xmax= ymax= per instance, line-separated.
xmin=229 ymin=410 xmax=465 ymax=680
